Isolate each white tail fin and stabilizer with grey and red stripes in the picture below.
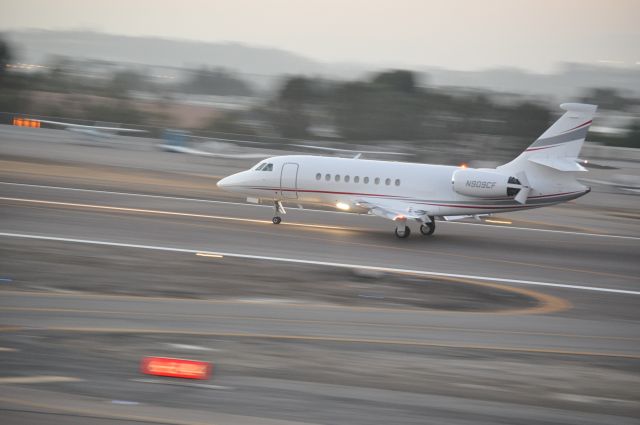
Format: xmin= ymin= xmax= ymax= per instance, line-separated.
xmin=497 ymin=103 xmax=598 ymax=204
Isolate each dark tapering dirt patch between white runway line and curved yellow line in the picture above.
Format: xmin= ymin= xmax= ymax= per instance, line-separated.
xmin=0 ymin=239 xmax=540 ymax=311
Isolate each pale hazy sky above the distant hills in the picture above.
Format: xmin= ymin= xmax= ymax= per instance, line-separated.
xmin=0 ymin=0 xmax=640 ymax=71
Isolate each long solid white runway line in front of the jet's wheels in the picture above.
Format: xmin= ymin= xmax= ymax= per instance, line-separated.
xmin=0 ymin=232 xmax=640 ymax=295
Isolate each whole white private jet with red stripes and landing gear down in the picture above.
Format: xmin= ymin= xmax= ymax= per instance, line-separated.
xmin=218 ymin=103 xmax=597 ymax=238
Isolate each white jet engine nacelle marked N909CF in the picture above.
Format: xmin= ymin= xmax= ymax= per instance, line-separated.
xmin=451 ymin=169 xmax=522 ymax=198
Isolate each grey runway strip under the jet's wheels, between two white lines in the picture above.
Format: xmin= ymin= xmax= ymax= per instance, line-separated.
xmin=0 ymin=180 xmax=640 ymax=290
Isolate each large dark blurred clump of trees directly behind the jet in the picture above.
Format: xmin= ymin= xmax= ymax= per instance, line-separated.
xmin=260 ymin=70 xmax=551 ymax=141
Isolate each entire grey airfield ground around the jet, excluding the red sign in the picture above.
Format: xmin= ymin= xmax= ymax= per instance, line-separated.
xmin=0 ymin=126 xmax=640 ymax=424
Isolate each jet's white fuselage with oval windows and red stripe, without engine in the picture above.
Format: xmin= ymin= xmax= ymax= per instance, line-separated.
xmin=219 ymin=155 xmax=589 ymax=216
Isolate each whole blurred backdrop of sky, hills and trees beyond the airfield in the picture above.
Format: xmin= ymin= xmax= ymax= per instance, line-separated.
xmin=0 ymin=1 xmax=640 ymax=162
